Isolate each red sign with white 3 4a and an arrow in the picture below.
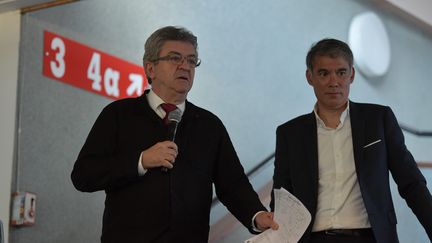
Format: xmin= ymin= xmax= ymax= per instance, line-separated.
xmin=43 ymin=31 xmax=148 ymax=99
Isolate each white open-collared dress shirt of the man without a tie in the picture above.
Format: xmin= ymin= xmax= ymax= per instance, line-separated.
xmin=312 ymin=104 xmax=370 ymax=232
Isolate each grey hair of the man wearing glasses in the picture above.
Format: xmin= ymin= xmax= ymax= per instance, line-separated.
xmin=143 ymin=26 xmax=198 ymax=83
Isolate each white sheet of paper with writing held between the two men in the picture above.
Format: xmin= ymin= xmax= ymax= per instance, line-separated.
xmin=245 ymin=188 xmax=311 ymax=243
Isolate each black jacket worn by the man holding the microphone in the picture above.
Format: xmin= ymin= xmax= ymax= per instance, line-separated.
xmin=71 ymin=95 xmax=265 ymax=243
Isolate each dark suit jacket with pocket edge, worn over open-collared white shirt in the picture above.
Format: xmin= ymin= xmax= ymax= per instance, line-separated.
xmin=271 ymin=102 xmax=432 ymax=243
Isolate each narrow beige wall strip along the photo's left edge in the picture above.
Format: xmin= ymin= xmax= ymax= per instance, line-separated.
xmin=0 ymin=11 xmax=20 ymax=242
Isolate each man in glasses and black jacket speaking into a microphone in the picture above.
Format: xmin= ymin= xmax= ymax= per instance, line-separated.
xmin=71 ymin=26 xmax=277 ymax=243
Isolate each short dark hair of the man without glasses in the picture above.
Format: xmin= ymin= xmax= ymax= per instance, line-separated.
xmin=306 ymin=38 xmax=354 ymax=70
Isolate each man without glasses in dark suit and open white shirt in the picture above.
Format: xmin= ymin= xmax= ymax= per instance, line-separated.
xmin=272 ymin=39 xmax=432 ymax=243
